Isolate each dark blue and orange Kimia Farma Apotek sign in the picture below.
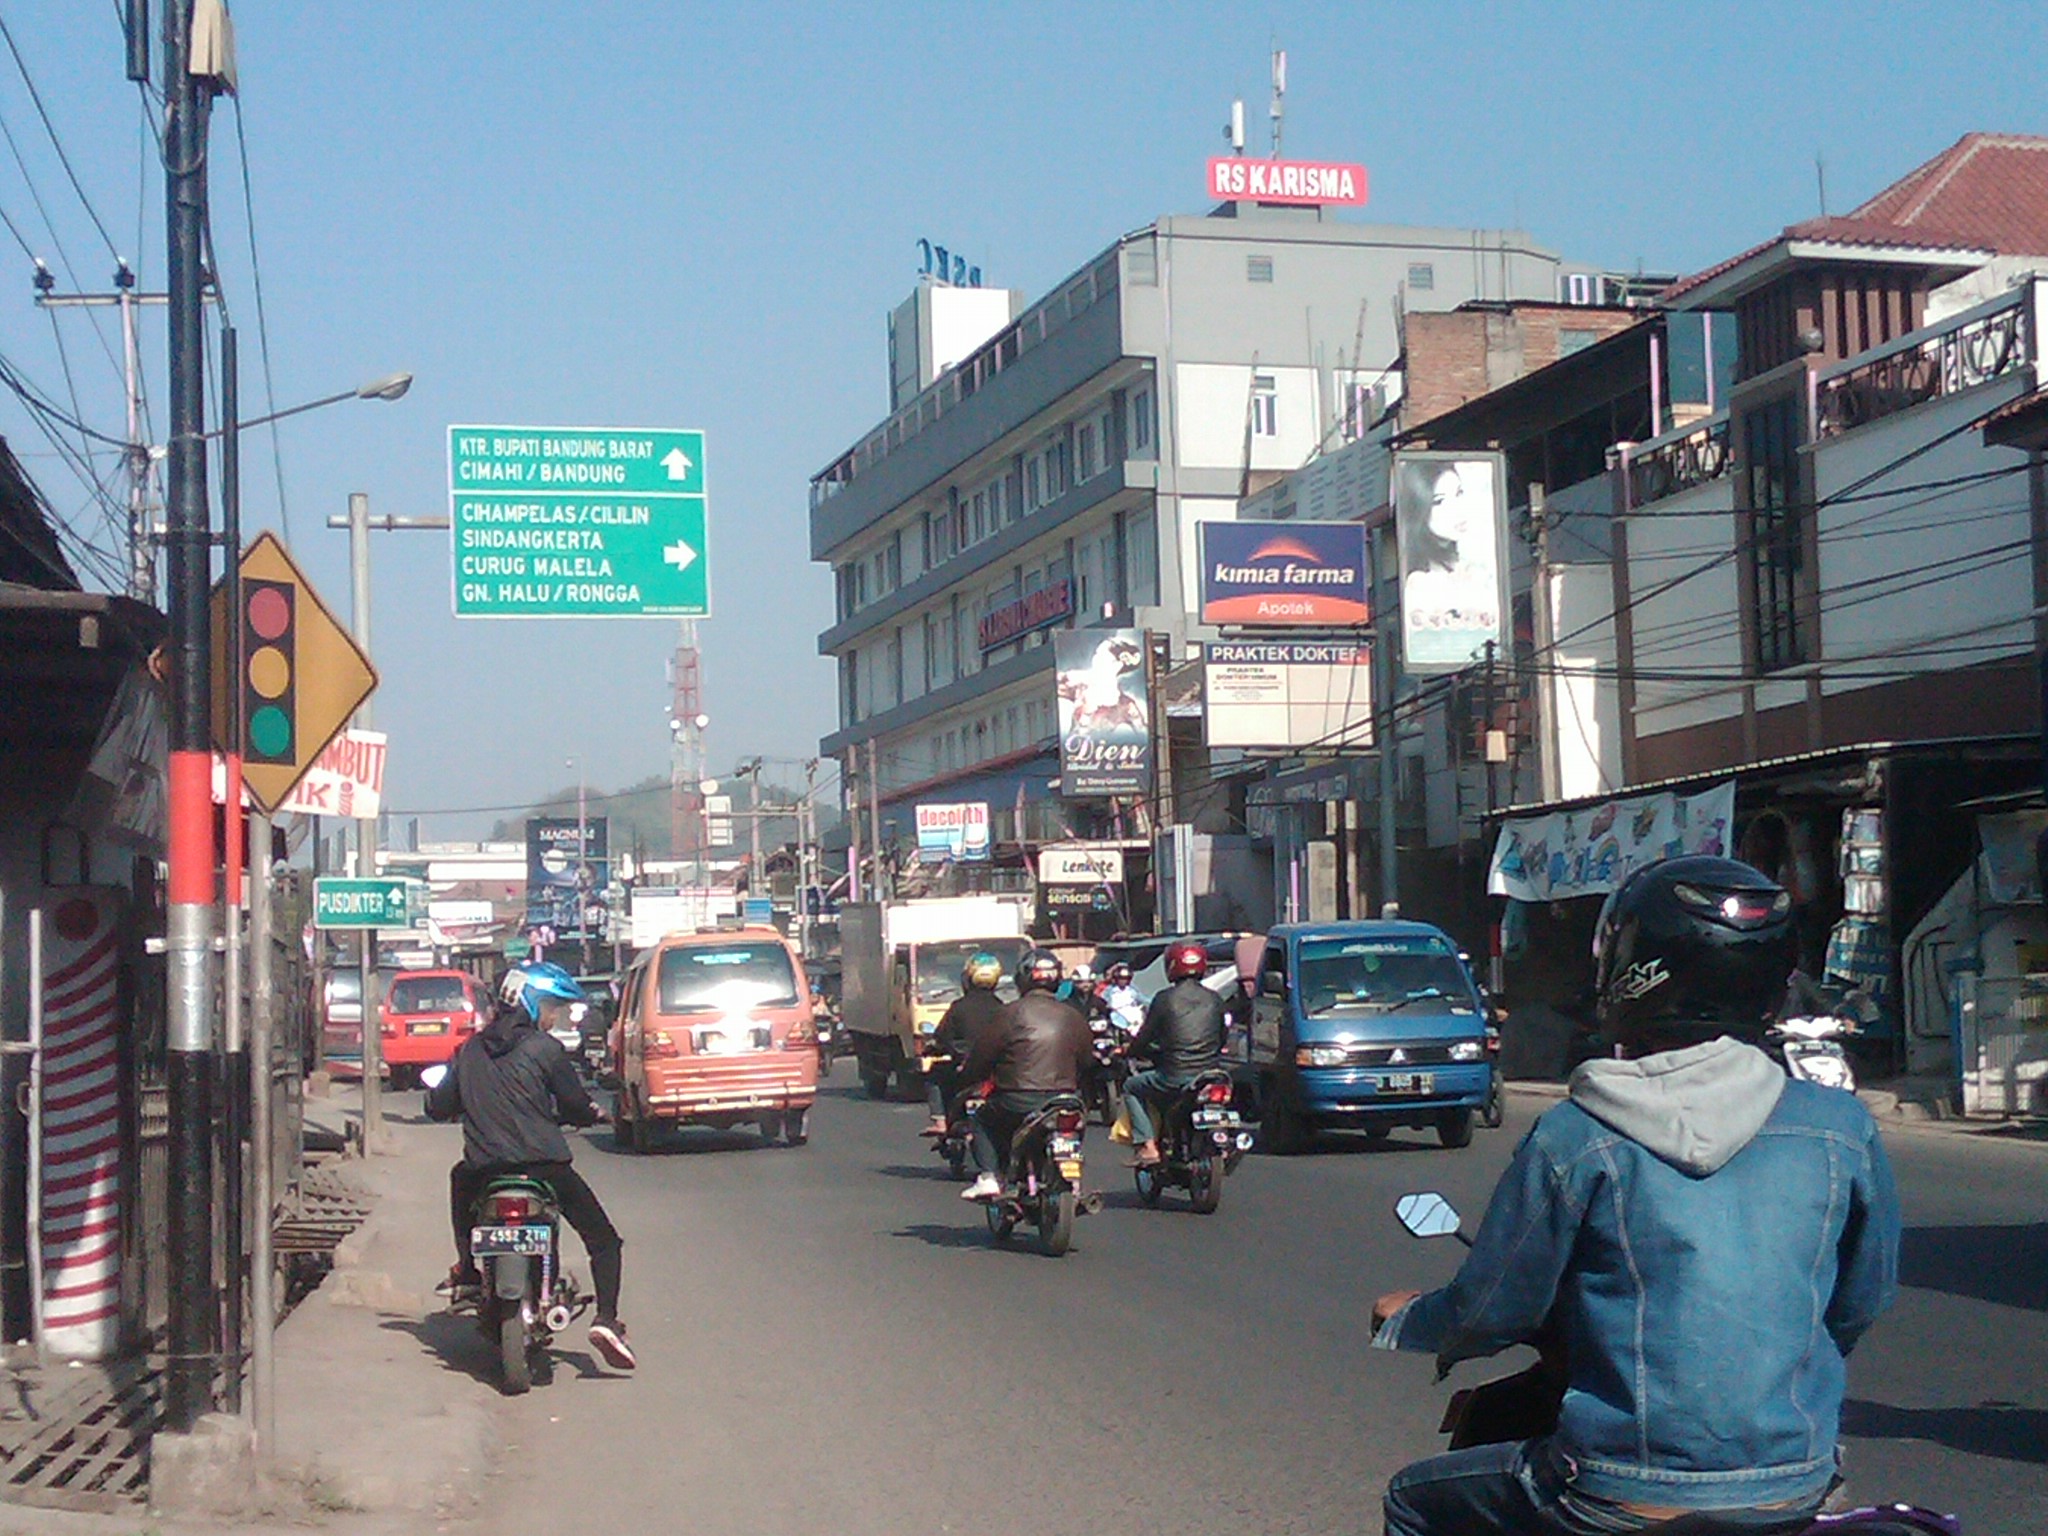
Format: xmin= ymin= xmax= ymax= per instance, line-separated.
xmin=1198 ymin=522 xmax=1372 ymax=629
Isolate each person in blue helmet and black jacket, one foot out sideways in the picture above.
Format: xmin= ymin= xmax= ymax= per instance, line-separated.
xmin=426 ymin=961 xmax=637 ymax=1370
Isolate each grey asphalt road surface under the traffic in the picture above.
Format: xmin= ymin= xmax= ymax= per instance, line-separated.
xmin=464 ymin=1063 xmax=2048 ymax=1536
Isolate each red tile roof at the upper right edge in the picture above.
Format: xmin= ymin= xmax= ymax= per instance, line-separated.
xmin=1659 ymin=133 xmax=2048 ymax=303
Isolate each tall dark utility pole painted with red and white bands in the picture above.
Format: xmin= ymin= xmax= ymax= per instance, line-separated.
xmin=164 ymin=0 xmax=215 ymax=1432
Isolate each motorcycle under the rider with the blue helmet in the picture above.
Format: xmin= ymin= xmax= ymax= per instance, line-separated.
xmin=469 ymin=1174 xmax=592 ymax=1397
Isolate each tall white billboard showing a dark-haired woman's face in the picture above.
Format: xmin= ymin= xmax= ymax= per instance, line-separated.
xmin=1395 ymin=453 xmax=1507 ymax=674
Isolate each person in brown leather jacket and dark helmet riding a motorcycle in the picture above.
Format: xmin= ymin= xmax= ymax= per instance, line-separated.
xmin=958 ymin=948 xmax=1092 ymax=1200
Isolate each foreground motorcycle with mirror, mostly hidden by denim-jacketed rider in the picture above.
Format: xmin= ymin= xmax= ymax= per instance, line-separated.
xmin=1395 ymin=1192 xmax=1962 ymax=1536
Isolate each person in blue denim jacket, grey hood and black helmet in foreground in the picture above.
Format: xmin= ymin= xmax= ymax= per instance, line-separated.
xmin=1372 ymin=856 xmax=1898 ymax=1536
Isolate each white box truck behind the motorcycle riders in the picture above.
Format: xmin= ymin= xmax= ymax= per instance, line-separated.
xmin=840 ymin=895 xmax=1030 ymax=1098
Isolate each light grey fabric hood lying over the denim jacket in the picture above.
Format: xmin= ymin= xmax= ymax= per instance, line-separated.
xmin=1571 ymin=1036 xmax=1786 ymax=1178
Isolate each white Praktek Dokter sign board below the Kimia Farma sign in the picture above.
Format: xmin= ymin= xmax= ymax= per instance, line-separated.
xmin=1202 ymin=641 xmax=1372 ymax=750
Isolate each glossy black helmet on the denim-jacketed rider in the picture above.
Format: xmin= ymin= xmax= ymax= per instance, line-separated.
xmin=1593 ymin=856 xmax=1798 ymax=1055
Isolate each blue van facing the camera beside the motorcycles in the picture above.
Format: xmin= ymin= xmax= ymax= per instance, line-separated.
xmin=1243 ymin=922 xmax=1493 ymax=1155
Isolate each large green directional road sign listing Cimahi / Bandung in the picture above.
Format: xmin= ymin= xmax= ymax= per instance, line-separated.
xmin=449 ymin=426 xmax=711 ymax=618
